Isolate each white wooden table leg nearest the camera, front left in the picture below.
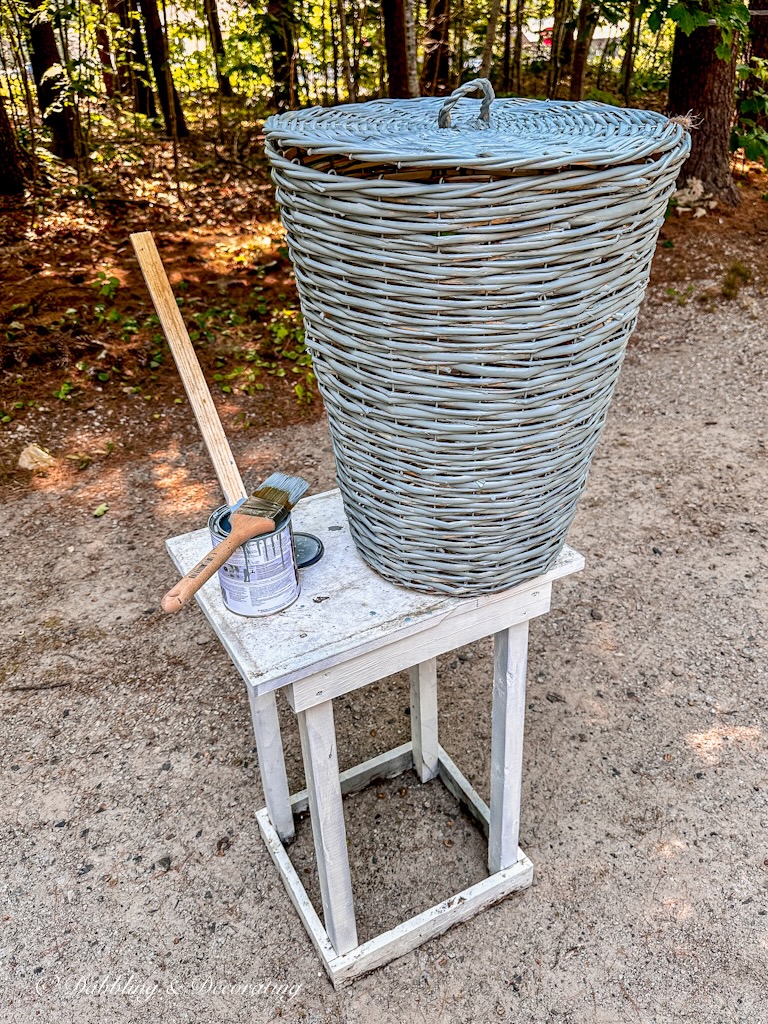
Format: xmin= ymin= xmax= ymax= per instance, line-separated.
xmin=296 ymin=700 xmax=357 ymax=954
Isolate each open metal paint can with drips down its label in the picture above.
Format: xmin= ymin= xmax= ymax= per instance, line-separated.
xmin=208 ymin=505 xmax=301 ymax=615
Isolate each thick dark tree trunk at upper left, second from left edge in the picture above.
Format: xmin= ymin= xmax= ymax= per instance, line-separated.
xmin=29 ymin=0 xmax=83 ymax=160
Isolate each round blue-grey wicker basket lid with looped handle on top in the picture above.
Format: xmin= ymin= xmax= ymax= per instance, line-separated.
xmin=264 ymin=78 xmax=688 ymax=171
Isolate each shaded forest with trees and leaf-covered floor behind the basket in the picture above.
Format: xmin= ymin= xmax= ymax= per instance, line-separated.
xmin=0 ymin=0 xmax=768 ymax=429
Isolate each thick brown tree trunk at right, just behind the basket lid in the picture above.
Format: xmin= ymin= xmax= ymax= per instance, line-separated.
xmin=669 ymin=26 xmax=740 ymax=206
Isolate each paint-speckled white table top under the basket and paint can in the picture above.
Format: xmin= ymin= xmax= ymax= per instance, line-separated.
xmin=166 ymin=490 xmax=584 ymax=693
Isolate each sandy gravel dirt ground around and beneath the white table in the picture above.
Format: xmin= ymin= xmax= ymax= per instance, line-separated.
xmin=0 ymin=180 xmax=768 ymax=1024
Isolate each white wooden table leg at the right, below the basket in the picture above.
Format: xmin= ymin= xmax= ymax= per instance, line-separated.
xmin=488 ymin=621 xmax=528 ymax=873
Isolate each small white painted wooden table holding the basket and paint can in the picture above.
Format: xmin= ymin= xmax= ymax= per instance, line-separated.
xmin=168 ymin=490 xmax=584 ymax=987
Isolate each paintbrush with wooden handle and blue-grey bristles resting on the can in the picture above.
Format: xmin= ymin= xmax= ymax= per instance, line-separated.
xmin=160 ymin=473 xmax=309 ymax=611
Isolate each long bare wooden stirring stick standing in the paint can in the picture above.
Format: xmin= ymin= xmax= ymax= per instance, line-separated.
xmin=130 ymin=231 xmax=248 ymax=506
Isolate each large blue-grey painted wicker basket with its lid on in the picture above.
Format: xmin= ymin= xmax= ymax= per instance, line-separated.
xmin=265 ymin=79 xmax=690 ymax=595
